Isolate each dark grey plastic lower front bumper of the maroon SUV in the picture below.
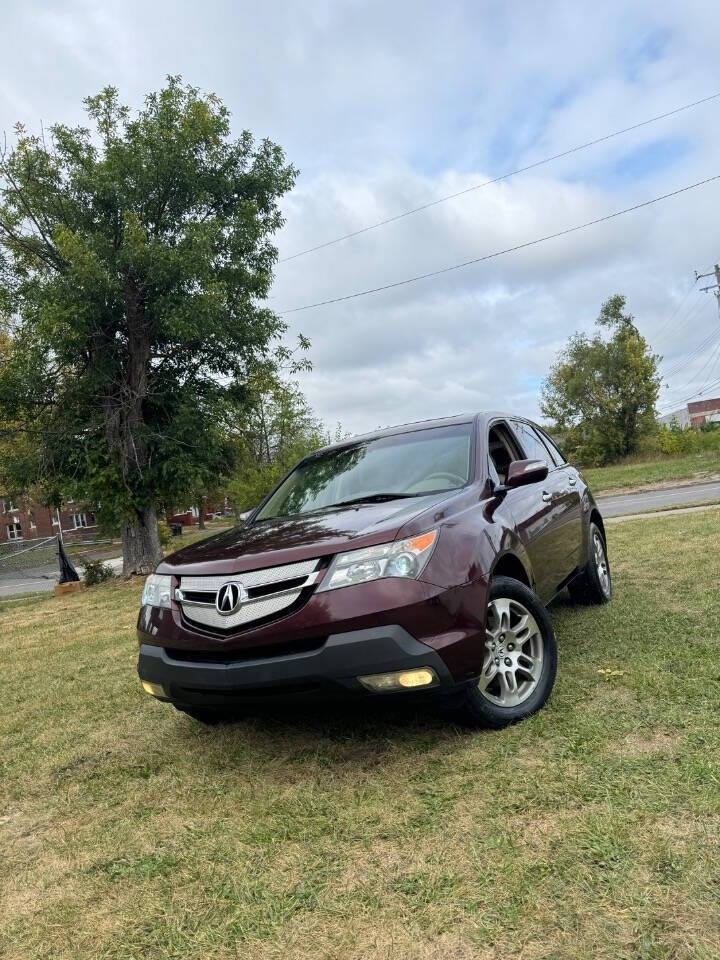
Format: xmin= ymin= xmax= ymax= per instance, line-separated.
xmin=138 ymin=626 xmax=457 ymax=708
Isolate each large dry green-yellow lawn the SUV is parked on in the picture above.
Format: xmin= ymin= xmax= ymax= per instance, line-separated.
xmin=0 ymin=511 xmax=720 ymax=960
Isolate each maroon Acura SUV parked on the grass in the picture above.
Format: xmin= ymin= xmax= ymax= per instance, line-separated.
xmin=138 ymin=413 xmax=611 ymax=727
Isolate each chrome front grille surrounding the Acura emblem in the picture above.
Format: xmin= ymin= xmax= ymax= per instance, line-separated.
xmin=175 ymin=560 xmax=320 ymax=632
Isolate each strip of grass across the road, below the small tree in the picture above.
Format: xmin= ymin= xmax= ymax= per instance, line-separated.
xmin=582 ymin=450 xmax=720 ymax=493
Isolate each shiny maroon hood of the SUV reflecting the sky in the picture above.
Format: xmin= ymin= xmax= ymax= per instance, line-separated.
xmin=158 ymin=491 xmax=456 ymax=575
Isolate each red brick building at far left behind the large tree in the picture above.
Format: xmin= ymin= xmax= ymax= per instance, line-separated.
xmin=0 ymin=496 xmax=97 ymax=543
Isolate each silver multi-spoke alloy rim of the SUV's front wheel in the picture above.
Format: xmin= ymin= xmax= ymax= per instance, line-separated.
xmin=478 ymin=596 xmax=544 ymax=707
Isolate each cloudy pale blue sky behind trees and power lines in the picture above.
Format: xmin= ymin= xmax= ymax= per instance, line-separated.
xmin=0 ymin=0 xmax=720 ymax=432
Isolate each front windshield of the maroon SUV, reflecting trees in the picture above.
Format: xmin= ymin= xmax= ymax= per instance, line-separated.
xmin=255 ymin=423 xmax=472 ymax=520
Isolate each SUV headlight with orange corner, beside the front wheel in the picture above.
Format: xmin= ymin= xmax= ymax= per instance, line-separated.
xmin=318 ymin=530 xmax=437 ymax=591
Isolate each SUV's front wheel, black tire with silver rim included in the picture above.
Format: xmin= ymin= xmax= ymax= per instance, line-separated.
xmin=464 ymin=577 xmax=557 ymax=730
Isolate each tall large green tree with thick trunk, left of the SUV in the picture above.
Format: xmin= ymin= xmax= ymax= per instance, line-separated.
xmin=0 ymin=77 xmax=296 ymax=573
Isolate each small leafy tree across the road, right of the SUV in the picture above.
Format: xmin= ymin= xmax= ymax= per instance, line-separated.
xmin=540 ymin=294 xmax=660 ymax=464
